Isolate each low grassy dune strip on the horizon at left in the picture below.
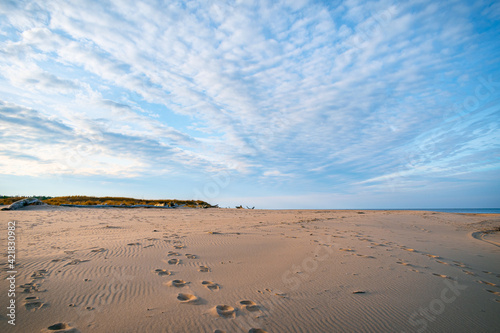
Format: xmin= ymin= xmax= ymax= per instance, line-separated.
xmin=0 ymin=195 xmax=212 ymax=208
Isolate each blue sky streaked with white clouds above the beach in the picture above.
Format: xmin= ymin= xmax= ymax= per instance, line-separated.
xmin=0 ymin=0 xmax=500 ymax=209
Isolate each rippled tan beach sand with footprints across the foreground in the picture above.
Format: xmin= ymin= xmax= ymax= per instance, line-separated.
xmin=0 ymin=207 xmax=500 ymax=333
